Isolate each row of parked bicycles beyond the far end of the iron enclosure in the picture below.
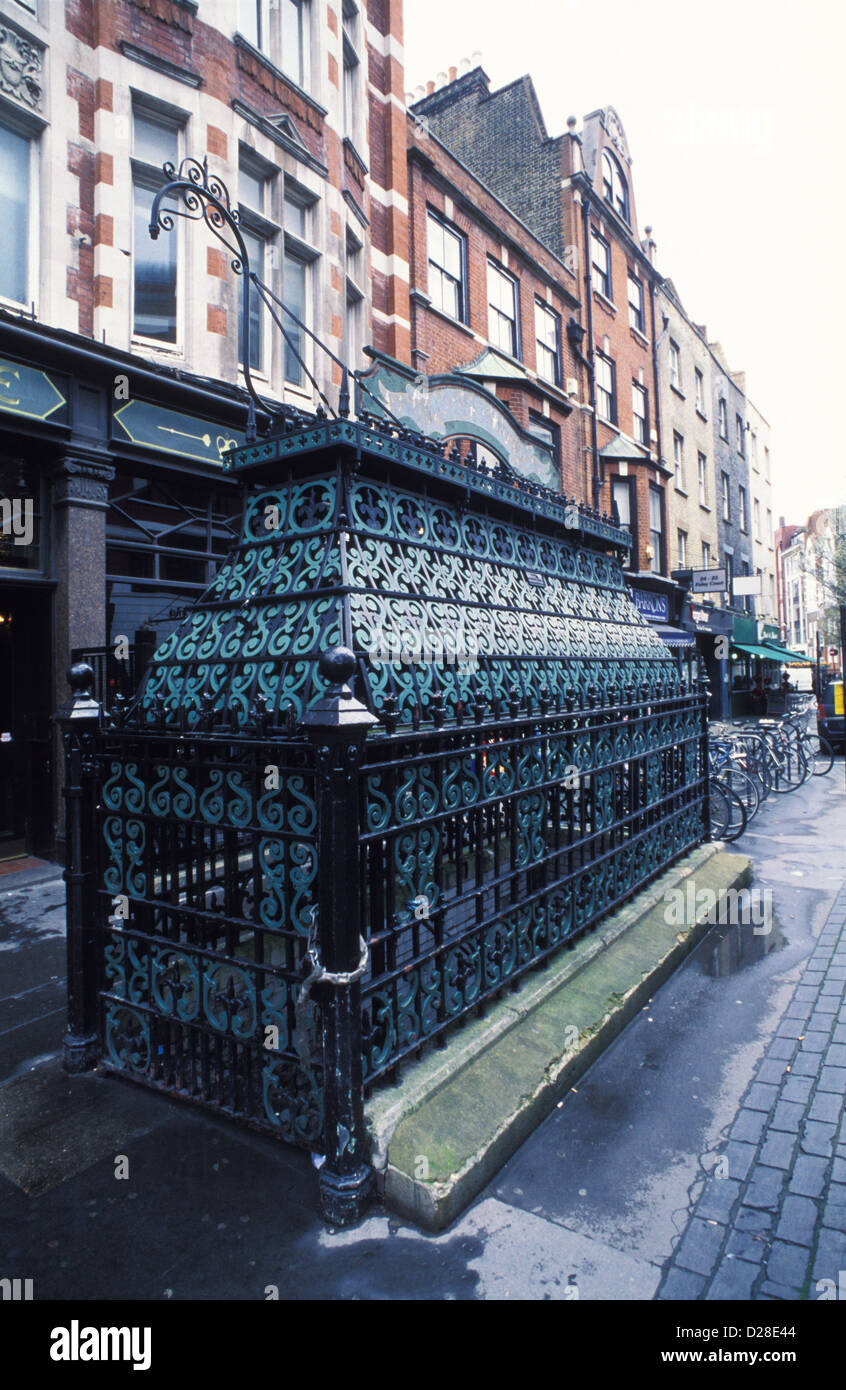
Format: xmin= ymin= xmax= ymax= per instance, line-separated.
xmin=708 ymin=698 xmax=833 ymax=840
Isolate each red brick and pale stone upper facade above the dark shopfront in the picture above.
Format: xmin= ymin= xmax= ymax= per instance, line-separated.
xmin=11 ymin=0 xmax=410 ymax=407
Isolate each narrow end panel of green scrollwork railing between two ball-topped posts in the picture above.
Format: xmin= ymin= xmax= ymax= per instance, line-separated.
xmin=93 ymin=720 xmax=322 ymax=1148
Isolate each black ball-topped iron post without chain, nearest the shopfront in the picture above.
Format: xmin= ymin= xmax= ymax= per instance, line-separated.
xmin=56 ymin=662 xmax=100 ymax=1072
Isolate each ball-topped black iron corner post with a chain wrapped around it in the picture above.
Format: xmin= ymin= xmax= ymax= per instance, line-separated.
xmin=304 ymin=646 xmax=378 ymax=1226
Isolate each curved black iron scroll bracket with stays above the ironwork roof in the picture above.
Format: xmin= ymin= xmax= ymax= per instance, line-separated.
xmin=150 ymin=156 xmax=400 ymax=443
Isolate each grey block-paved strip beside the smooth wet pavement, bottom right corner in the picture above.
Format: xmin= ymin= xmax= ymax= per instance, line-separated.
xmin=656 ymin=885 xmax=846 ymax=1300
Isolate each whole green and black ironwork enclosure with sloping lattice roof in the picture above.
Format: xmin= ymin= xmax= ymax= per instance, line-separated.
xmin=60 ymin=164 xmax=708 ymax=1223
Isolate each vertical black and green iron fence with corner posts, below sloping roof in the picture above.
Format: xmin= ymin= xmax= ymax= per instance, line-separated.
xmin=63 ymin=653 xmax=707 ymax=1220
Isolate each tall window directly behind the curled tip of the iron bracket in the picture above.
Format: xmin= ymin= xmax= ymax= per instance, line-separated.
xmin=132 ymin=111 xmax=179 ymax=343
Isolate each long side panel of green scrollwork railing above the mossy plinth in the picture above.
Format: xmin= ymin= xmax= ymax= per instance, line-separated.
xmin=360 ymin=687 xmax=707 ymax=1084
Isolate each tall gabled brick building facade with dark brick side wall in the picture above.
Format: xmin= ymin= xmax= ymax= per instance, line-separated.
xmin=414 ymin=76 xmax=668 ymax=573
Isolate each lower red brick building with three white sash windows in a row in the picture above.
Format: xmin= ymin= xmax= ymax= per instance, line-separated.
xmin=408 ymin=117 xmax=585 ymax=496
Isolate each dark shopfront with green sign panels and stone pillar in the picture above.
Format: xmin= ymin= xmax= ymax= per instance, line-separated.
xmin=0 ymin=311 xmax=247 ymax=859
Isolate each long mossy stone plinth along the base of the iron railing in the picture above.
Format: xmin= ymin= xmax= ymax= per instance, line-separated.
xmin=367 ymin=844 xmax=752 ymax=1232
